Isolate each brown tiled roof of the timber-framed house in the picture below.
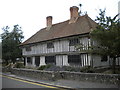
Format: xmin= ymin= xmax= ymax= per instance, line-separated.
xmin=21 ymin=15 xmax=97 ymax=45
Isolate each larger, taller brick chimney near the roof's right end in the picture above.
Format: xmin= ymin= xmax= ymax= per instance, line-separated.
xmin=69 ymin=6 xmax=79 ymax=24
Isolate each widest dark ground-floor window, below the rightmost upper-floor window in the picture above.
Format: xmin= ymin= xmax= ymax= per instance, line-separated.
xmin=68 ymin=55 xmax=81 ymax=64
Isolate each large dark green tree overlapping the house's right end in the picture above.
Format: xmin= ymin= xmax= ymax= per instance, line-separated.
xmin=77 ymin=10 xmax=120 ymax=73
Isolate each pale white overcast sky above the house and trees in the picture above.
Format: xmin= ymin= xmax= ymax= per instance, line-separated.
xmin=0 ymin=0 xmax=120 ymax=41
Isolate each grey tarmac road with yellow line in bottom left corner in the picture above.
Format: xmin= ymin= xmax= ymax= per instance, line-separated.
xmin=2 ymin=75 xmax=66 ymax=89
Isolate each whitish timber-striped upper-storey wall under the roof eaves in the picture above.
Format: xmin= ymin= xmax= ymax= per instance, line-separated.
xmin=22 ymin=37 xmax=89 ymax=55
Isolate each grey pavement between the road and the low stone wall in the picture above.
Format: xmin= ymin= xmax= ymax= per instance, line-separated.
xmin=3 ymin=73 xmax=120 ymax=90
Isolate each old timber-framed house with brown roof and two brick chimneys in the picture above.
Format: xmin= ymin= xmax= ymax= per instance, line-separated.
xmin=20 ymin=6 xmax=120 ymax=67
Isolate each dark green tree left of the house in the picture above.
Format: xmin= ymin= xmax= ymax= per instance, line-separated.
xmin=1 ymin=25 xmax=24 ymax=64
